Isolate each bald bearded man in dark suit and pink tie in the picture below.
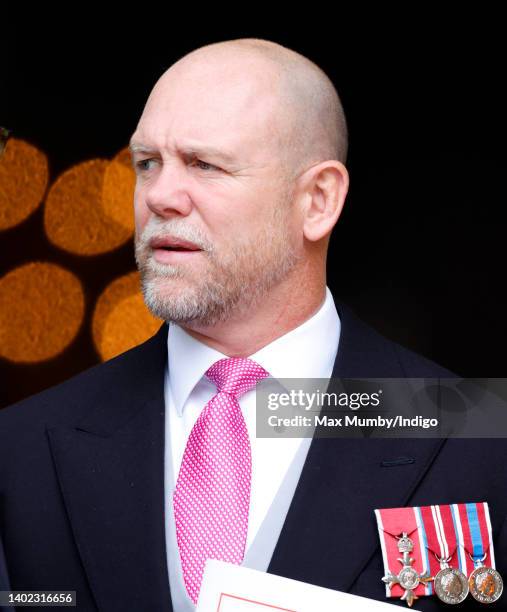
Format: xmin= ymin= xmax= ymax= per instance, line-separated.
xmin=0 ymin=39 xmax=507 ymax=612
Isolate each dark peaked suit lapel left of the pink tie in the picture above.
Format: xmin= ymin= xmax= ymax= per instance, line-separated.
xmin=48 ymin=325 xmax=172 ymax=612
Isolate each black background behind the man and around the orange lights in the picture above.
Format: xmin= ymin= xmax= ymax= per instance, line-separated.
xmin=0 ymin=9 xmax=507 ymax=406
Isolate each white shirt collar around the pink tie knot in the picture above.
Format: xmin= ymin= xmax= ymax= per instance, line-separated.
xmin=167 ymin=286 xmax=340 ymax=416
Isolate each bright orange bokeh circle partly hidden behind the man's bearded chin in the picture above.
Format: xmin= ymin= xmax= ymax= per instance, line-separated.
xmin=92 ymin=272 xmax=163 ymax=361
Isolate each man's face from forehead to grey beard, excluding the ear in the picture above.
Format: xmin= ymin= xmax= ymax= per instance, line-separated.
xmin=131 ymin=57 xmax=302 ymax=326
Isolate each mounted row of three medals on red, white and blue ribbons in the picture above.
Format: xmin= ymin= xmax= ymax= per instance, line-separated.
xmin=375 ymin=502 xmax=503 ymax=607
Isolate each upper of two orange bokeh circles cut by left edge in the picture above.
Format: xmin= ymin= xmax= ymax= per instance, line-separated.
xmin=0 ymin=138 xmax=48 ymax=230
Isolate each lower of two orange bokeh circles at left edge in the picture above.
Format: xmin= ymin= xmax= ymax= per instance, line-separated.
xmin=0 ymin=262 xmax=85 ymax=363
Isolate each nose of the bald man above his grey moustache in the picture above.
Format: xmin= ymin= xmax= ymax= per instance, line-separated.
xmin=144 ymin=162 xmax=192 ymax=217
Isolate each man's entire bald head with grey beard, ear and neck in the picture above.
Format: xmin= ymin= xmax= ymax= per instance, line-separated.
xmin=131 ymin=39 xmax=348 ymax=342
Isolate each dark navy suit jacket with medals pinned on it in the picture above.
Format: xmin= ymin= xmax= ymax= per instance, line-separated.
xmin=0 ymin=304 xmax=507 ymax=612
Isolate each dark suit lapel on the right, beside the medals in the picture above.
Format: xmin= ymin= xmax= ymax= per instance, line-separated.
xmin=268 ymin=305 xmax=443 ymax=591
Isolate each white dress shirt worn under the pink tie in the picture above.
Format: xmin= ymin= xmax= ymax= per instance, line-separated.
xmin=164 ymin=287 xmax=340 ymax=612
